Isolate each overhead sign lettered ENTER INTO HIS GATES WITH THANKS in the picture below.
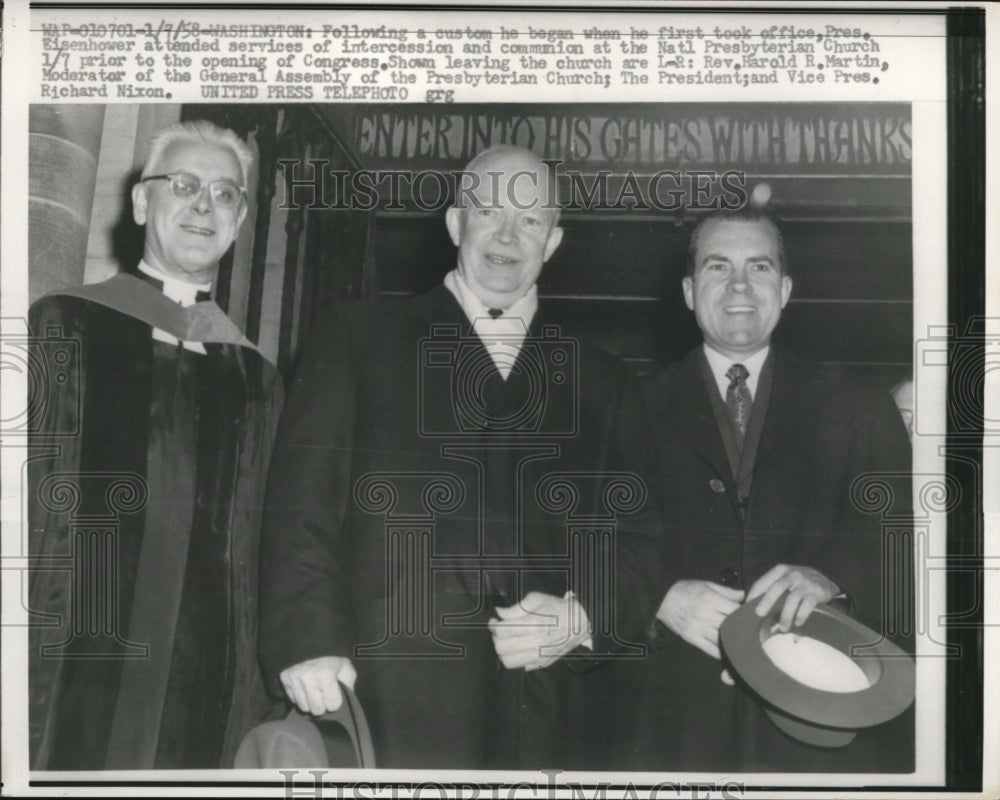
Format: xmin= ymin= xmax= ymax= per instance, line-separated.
xmin=346 ymin=103 xmax=912 ymax=176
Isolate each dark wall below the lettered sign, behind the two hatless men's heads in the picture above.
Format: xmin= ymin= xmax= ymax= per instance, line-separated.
xmin=374 ymin=214 xmax=912 ymax=381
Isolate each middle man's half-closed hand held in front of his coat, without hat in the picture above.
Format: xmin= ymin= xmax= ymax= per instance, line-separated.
xmin=489 ymin=592 xmax=591 ymax=672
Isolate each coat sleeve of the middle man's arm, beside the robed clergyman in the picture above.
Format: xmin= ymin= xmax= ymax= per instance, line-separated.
xmin=259 ymin=311 xmax=356 ymax=694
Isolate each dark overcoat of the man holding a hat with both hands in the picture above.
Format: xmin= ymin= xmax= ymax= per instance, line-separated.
xmin=617 ymin=346 xmax=913 ymax=772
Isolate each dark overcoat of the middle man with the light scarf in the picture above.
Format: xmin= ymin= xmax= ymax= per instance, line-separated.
xmin=261 ymin=287 xmax=657 ymax=768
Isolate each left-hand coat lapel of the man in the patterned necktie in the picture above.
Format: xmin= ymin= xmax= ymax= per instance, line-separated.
xmin=648 ymin=346 xmax=733 ymax=484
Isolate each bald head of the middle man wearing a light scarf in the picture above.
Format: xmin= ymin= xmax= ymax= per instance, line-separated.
xmin=445 ymin=145 xmax=562 ymax=308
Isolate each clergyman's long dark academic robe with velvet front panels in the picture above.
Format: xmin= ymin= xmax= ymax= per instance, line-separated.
xmin=28 ymin=275 xmax=282 ymax=770
